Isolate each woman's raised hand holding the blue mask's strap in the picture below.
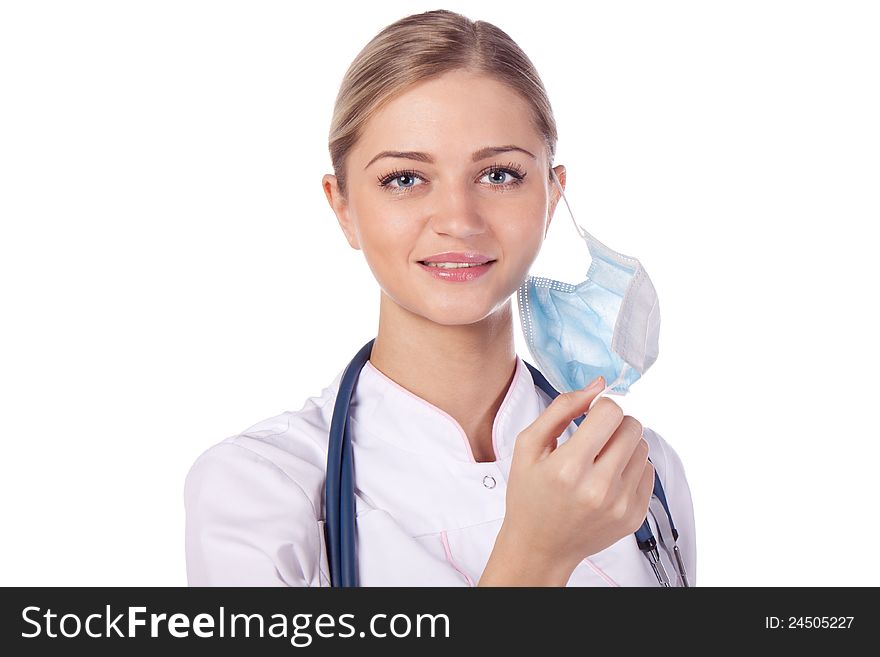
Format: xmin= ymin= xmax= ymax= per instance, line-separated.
xmin=499 ymin=377 xmax=654 ymax=581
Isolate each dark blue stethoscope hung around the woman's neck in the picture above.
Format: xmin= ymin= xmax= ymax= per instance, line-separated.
xmin=324 ymin=338 xmax=688 ymax=587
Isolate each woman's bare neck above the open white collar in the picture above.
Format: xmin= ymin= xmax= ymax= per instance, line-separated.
xmin=370 ymin=292 xmax=516 ymax=461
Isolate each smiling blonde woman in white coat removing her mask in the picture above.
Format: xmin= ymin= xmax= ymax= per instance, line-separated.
xmin=186 ymin=10 xmax=696 ymax=586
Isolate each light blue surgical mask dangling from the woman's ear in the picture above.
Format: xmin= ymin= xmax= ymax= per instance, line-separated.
xmin=516 ymin=169 xmax=660 ymax=394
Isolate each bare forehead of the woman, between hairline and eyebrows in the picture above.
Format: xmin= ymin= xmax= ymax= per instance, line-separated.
xmin=351 ymin=71 xmax=543 ymax=167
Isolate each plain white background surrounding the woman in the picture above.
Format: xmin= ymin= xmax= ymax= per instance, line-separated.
xmin=0 ymin=0 xmax=880 ymax=586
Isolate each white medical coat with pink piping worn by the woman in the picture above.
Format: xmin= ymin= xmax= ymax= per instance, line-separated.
xmin=184 ymin=357 xmax=696 ymax=586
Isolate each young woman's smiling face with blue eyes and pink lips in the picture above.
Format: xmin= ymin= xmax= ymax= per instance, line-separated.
xmin=324 ymin=71 xmax=565 ymax=325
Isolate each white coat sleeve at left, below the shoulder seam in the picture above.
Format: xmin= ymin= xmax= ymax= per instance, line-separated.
xmin=184 ymin=436 xmax=330 ymax=586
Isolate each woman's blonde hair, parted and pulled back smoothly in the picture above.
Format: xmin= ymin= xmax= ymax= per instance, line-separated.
xmin=329 ymin=9 xmax=557 ymax=197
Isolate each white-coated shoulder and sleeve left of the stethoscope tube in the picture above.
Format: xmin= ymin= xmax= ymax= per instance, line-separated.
xmin=184 ymin=376 xmax=344 ymax=586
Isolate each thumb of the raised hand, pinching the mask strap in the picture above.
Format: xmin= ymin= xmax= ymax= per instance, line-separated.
xmin=514 ymin=376 xmax=605 ymax=463
